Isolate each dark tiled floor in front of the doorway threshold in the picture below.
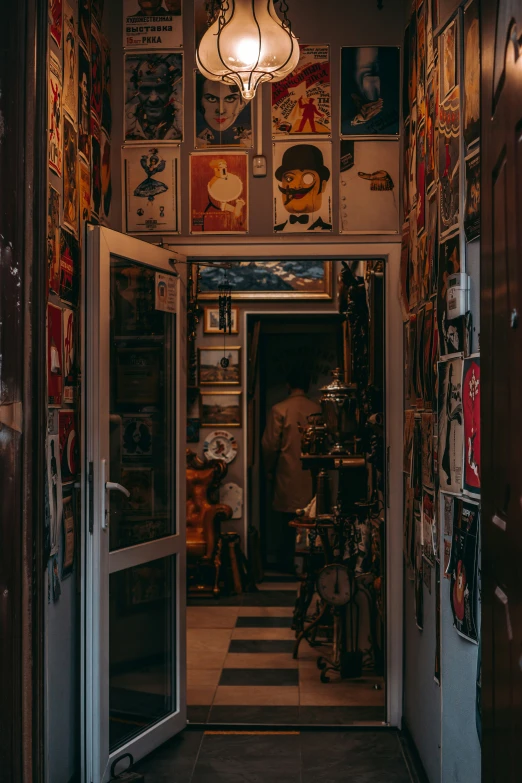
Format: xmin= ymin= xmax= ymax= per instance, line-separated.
xmin=136 ymin=730 xmax=417 ymax=783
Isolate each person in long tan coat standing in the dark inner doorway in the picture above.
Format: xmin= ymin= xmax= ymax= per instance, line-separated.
xmin=262 ymin=367 xmax=321 ymax=573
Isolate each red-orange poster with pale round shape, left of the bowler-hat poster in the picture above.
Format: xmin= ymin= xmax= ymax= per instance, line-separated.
xmin=190 ymin=152 xmax=249 ymax=234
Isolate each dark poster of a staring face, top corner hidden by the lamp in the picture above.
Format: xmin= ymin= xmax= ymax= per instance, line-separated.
xmin=194 ymin=70 xmax=253 ymax=149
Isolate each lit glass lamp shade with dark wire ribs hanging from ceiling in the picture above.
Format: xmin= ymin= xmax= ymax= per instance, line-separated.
xmin=196 ymin=0 xmax=299 ymax=100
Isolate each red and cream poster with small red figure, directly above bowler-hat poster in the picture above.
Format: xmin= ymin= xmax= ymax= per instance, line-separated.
xmin=272 ymin=44 xmax=332 ymax=138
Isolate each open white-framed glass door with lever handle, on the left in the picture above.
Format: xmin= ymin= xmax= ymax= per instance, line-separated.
xmin=82 ymin=226 xmax=186 ymax=783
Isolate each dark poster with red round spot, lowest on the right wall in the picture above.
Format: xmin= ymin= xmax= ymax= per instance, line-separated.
xmin=448 ymin=498 xmax=479 ymax=644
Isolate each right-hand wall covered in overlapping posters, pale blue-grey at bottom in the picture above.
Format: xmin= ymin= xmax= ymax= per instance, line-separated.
xmin=400 ymin=0 xmax=480 ymax=780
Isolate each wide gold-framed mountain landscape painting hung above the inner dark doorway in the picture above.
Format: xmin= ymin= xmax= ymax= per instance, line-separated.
xmin=199 ymin=258 xmax=333 ymax=299
